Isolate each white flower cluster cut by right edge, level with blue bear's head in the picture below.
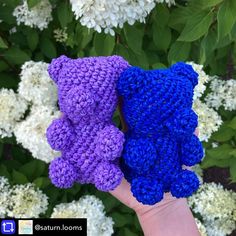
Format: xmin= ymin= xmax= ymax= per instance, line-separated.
xmin=205 ymin=77 xmax=236 ymax=111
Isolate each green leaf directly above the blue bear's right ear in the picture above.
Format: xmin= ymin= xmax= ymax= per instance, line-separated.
xmin=168 ymin=41 xmax=191 ymax=64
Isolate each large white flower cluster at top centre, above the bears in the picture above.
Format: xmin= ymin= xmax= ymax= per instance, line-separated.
xmin=70 ymin=0 xmax=175 ymax=35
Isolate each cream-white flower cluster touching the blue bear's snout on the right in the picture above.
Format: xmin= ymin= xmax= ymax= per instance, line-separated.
xmin=193 ymin=99 xmax=222 ymax=141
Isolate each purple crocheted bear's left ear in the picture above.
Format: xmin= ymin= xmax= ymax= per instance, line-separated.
xmin=48 ymin=55 xmax=70 ymax=83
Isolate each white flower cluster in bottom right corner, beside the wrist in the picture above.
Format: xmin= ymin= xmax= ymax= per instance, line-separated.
xmin=188 ymin=183 xmax=236 ymax=236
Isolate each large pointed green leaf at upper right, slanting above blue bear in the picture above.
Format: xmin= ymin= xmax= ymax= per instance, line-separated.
xmin=178 ymin=11 xmax=213 ymax=42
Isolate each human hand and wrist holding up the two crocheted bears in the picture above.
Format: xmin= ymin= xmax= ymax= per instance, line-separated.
xmin=110 ymin=179 xmax=200 ymax=236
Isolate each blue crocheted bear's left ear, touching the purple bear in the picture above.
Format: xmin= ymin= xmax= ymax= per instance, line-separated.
xmin=117 ymin=66 xmax=144 ymax=96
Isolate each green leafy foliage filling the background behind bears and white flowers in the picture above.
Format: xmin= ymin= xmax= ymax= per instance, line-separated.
xmin=0 ymin=0 xmax=236 ymax=232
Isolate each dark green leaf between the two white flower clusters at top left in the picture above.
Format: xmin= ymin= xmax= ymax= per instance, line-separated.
xmin=57 ymin=1 xmax=73 ymax=28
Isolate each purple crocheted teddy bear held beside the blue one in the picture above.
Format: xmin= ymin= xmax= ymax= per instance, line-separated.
xmin=47 ymin=56 xmax=129 ymax=191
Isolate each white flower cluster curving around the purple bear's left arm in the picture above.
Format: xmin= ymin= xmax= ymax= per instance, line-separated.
xmin=14 ymin=106 xmax=60 ymax=162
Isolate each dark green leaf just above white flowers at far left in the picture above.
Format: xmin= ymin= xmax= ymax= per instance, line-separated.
xmin=3 ymin=47 xmax=30 ymax=65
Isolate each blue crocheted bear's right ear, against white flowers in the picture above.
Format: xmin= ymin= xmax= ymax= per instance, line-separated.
xmin=170 ymin=62 xmax=198 ymax=88
